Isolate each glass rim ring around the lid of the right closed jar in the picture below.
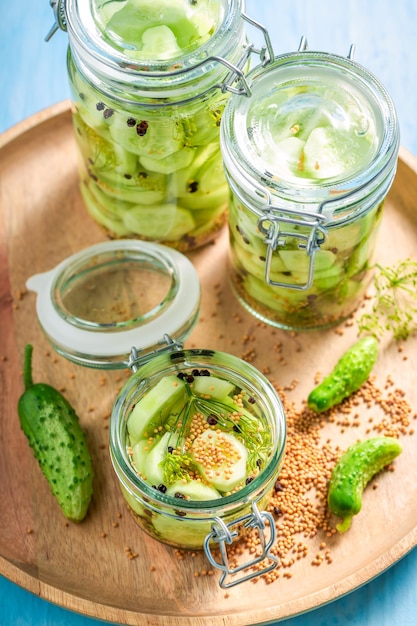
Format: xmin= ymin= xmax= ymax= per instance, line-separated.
xmin=221 ymin=50 xmax=399 ymax=212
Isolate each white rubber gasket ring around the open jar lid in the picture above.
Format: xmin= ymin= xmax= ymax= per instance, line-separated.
xmin=26 ymin=239 xmax=201 ymax=360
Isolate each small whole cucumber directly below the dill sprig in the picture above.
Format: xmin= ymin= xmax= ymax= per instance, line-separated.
xmin=307 ymin=336 xmax=378 ymax=413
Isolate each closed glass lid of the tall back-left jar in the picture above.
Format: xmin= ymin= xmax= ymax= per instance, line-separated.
xmin=60 ymin=0 xmax=243 ymax=89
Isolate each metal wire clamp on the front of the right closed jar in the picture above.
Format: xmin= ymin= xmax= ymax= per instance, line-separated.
xmin=258 ymin=204 xmax=327 ymax=290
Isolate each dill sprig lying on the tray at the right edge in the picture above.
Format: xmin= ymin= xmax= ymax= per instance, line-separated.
xmin=358 ymin=259 xmax=417 ymax=341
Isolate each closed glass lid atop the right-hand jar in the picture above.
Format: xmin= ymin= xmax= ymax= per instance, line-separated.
xmin=222 ymin=50 xmax=399 ymax=212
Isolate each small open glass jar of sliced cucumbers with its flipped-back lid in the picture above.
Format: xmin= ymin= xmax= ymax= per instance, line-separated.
xmin=27 ymin=239 xmax=286 ymax=587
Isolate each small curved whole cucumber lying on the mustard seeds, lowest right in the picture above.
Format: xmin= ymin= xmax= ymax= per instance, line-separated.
xmin=327 ymin=436 xmax=402 ymax=532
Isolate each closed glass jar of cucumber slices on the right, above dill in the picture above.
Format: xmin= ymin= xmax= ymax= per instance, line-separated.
xmin=221 ymin=42 xmax=399 ymax=330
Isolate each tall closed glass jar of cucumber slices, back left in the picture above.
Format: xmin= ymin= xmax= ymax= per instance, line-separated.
xmin=46 ymin=0 xmax=270 ymax=251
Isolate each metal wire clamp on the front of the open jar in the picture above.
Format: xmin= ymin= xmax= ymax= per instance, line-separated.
xmin=204 ymin=502 xmax=279 ymax=589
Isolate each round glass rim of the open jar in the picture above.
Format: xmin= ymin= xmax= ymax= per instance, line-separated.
xmin=110 ymin=349 xmax=287 ymax=519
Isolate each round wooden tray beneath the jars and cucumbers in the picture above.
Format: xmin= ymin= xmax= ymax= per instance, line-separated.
xmin=0 ymin=102 xmax=417 ymax=626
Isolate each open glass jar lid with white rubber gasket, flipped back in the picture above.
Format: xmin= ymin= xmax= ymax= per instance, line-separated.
xmin=27 ymin=239 xmax=200 ymax=369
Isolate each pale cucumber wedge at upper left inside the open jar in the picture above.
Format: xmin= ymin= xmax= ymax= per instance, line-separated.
xmin=127 ymin=375 xmax=187 ymax=445
